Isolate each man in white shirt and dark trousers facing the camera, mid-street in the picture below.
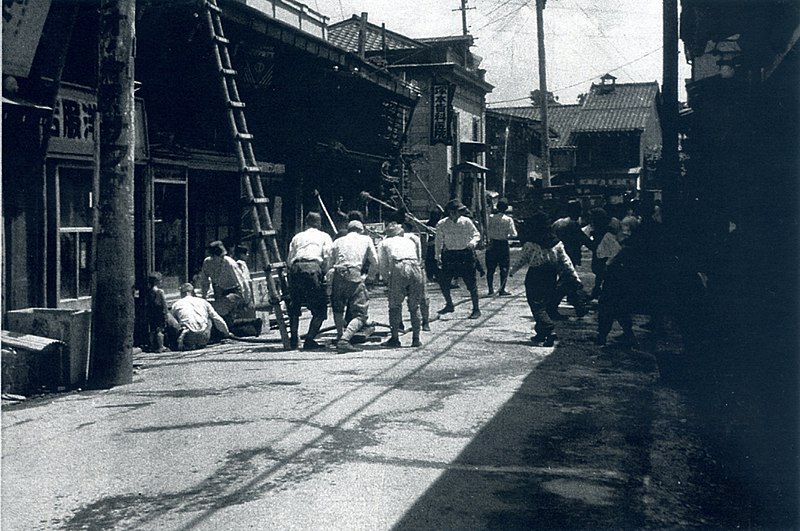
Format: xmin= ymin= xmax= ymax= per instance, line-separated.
xmin=435 ymin=199 xmax=481 ymax=319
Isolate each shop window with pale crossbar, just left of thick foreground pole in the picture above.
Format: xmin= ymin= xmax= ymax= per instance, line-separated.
xmin=58 ymin=167 xmax=94 ymax=300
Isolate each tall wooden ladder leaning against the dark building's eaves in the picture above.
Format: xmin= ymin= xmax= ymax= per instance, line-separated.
xmin=205 ymin=0 xmax=290 ymax=349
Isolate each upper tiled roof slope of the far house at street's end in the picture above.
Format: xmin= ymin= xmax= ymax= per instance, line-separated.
xmin=572 ymin=82 xmax=658 ymax=133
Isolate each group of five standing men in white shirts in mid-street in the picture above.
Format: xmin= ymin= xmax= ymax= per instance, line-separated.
xmin=287 ymin=195 xmax=517 ymax=352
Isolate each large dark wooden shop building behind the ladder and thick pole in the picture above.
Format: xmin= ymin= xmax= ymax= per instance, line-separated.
xmin=3 ymin=0 xmax=419 ymax=340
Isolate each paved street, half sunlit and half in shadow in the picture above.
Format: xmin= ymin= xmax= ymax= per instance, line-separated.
xmin=2 ymin=256 xmax=792 ymax=531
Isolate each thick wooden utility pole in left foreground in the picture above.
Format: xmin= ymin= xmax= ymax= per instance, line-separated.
xmin=90 ymin=0 xmax=136 ymax=388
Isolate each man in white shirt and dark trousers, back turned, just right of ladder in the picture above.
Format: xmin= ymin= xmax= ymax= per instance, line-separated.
xmin=286 ymin=212 xmax=333 ymax=350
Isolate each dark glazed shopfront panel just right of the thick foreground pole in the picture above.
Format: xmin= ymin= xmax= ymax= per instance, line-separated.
xmin=153 ymin=181 xmax=188 ymax=290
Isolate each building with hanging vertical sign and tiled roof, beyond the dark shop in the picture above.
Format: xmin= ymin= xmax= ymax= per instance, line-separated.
xmin=328 ymin=14 xmax=493 ymax=222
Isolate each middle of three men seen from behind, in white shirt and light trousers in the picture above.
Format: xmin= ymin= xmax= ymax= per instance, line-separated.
xmin=331 ymin=220 xmax=378 ymax=352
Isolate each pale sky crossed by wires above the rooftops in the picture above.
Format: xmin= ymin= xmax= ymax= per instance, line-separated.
xmin=310 ymin=0 xmax=689 ymax=106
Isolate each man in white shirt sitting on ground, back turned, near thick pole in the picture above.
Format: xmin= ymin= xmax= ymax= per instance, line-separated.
xmin=167 ymin=283 xmax=231 ymax=350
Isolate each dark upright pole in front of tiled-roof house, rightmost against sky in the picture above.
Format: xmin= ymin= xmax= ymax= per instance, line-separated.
xmin=661 ymin=0 xmax=680 ymax=204
